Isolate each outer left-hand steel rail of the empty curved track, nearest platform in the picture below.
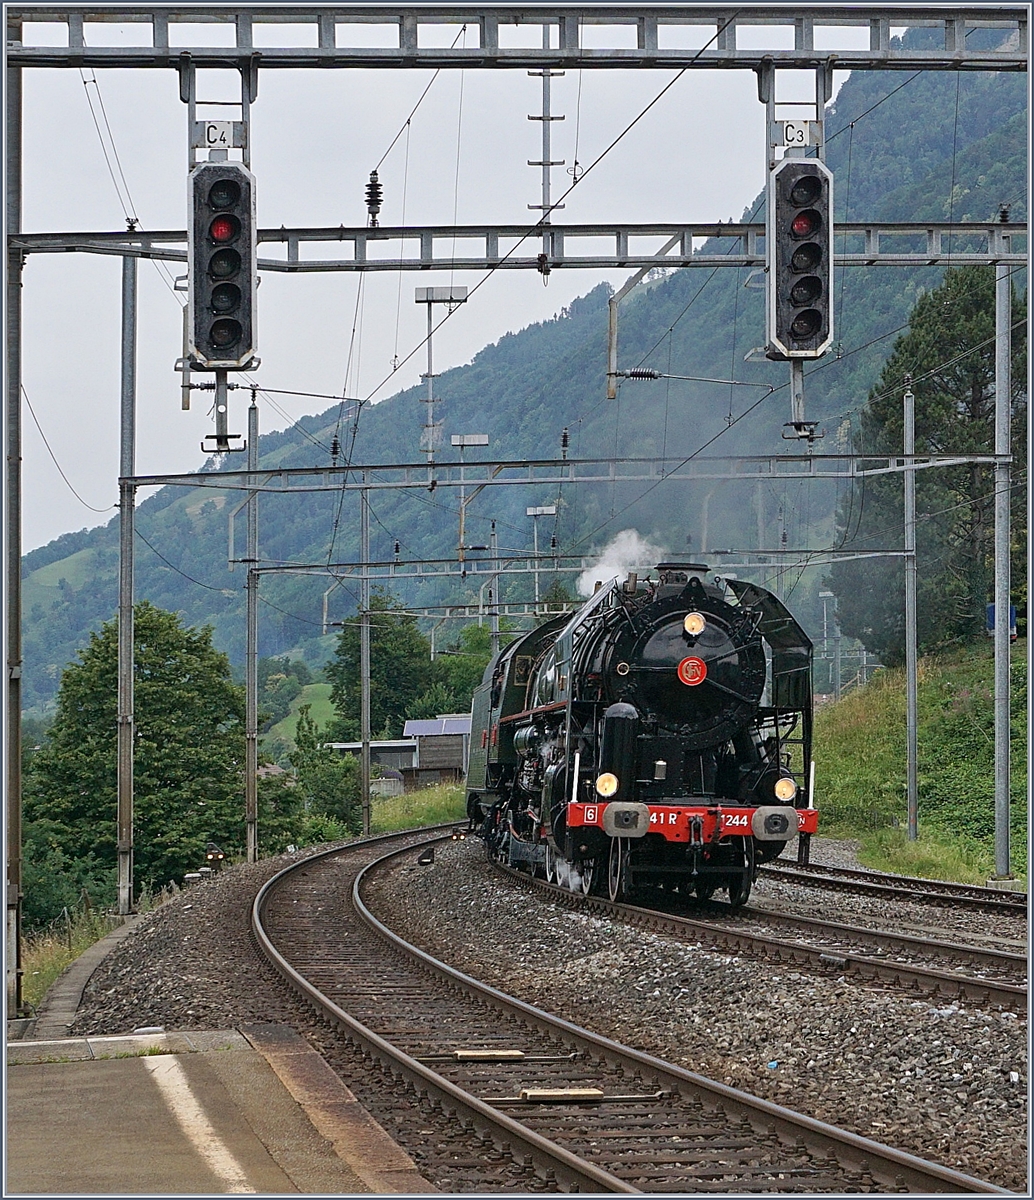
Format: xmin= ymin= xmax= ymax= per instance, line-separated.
xmin=251 ymin=822 xmax=638 ymax=1194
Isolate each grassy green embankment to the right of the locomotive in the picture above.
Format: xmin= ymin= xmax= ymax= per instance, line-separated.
xmin=814 ymin=641 xmax=1027 ymax=883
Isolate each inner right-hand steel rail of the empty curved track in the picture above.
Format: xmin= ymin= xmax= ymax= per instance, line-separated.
xmin=353 ymin=851 xmax=1010 ymax=1194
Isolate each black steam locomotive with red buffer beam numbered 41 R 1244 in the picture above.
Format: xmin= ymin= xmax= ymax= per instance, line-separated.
xmin=467 ymin=563 xmax=818 ymax=907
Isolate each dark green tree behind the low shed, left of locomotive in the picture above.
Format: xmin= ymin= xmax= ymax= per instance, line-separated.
xmin=325 ymin=588 xmax=432 ymax=742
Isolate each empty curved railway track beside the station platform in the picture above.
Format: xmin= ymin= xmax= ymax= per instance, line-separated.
xmin=252 ymin=832 xmax=1009 ymax=1194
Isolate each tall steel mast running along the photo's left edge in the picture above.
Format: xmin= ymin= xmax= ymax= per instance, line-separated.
xmin=5 ymin=37 xmax=25 ymax=1018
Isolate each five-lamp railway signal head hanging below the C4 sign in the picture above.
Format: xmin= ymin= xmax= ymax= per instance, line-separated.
xmin=187 ymin=162 xmax=258 ymax=370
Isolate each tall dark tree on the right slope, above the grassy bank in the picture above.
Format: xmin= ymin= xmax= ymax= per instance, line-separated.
xmin=830 ymin=266 xmax=1027 ymax=664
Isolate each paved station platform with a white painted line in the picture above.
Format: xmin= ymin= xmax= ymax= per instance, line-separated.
xmin=4 ymin=1025 xmax=435 ymax=1195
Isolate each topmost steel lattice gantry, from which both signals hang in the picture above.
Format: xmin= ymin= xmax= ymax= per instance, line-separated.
xmin=7 ymin=4 xmax=1028 ymax=71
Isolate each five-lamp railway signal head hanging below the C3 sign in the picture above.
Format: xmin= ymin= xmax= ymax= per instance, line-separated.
xmin=765 ymin=158 xmax=832 ymax=359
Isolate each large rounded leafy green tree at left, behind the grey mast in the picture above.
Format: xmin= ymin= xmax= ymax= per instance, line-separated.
xmin=25 ymin=601 xmax=245 ymax=912
